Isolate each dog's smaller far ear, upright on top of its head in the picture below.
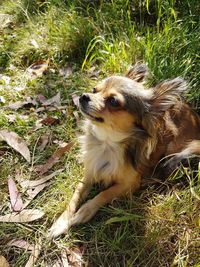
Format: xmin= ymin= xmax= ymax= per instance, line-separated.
xmin=125 ymin=63 xmax=149 ymax=82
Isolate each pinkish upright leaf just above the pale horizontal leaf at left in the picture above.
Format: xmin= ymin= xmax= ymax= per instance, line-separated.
xmin=8 ymin=177 xmax=23 ymax=211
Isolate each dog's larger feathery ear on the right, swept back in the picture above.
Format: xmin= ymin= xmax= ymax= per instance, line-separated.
xmin=151 ymin=77 xmax=187 ymax=111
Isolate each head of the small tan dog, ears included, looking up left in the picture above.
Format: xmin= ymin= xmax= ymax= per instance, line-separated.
xmin=79 ymin=65 xmax=186 ymax=135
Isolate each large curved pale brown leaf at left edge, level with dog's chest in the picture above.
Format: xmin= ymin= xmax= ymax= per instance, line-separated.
xmin=0 ymin=130 xmax=31 ymax=162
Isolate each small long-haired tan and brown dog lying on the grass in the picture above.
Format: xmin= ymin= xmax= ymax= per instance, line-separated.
xmin=50 ymin=64 xmax=200 ymax=238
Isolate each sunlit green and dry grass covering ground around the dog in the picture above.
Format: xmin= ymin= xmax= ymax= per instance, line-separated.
xmin=0 ymin=0 xmax=200 ymax=267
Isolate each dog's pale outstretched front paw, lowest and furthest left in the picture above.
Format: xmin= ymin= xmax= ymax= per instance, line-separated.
xmin=48 ymin=213 xmax=73 ymax=239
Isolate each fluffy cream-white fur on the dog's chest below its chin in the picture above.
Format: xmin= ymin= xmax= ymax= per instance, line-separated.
xmin=80 ymin=121 xmax=127 ymax=185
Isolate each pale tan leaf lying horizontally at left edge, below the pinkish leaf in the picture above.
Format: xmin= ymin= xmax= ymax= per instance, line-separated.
xmin=0 ymin=209 xmax=44 ymax=223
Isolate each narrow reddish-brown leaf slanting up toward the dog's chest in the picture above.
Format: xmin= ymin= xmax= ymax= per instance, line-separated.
xmin=35 ymin=142 xmax=74 ymax=175
